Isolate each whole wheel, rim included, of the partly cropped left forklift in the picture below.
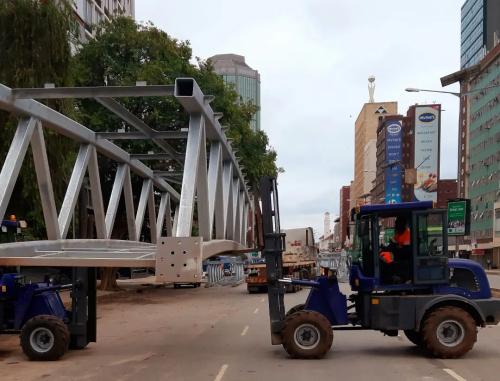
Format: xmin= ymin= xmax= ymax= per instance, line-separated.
xmin=21 ymin=315 xmax=70 ymax=361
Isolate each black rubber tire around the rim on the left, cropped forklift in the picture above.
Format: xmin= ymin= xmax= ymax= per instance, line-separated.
xmin=20 ymin=315 xmax=70 ymax=361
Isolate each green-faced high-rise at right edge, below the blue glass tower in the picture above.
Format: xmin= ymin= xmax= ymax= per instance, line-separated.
xmin=441 ymin=19 xmax=500 ymax=266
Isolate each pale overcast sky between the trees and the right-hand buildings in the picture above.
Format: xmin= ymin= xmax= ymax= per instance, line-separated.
xmin=136 ymin=0 xmax=464 ymax=238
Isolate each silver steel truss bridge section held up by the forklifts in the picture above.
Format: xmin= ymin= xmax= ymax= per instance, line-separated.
xmin=0 ymin=78 xmax=252 ymax=281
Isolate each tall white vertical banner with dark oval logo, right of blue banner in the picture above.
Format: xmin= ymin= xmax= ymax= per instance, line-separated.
xmin=414 ymin=105 xmax=441 ymax=202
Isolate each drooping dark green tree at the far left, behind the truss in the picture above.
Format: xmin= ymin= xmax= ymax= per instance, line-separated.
xmin=0 ymin=0 xmax=75 ymax=238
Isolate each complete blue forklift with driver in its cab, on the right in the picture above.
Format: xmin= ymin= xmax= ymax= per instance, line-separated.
xmin=261 ymin=178 xmax=500 ymax=359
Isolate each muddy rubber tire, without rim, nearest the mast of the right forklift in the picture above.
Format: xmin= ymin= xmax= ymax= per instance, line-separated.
xmin=282 ymin=310 xmax=333 ymax=359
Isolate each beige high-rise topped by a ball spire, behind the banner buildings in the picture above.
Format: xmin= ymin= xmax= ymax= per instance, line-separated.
xmin=350 ymin=102 xmax=398 ymax=206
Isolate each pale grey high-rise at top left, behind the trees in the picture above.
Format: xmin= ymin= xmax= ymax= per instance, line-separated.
xmin=73 ymin=0 xmax=135 ymax=42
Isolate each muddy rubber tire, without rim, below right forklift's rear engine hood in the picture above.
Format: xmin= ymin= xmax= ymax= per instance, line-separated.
xmin=422 ymin=306 xmax=477 ymax=359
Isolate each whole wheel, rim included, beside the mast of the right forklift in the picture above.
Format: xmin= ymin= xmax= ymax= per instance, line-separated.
xmin=282 ymin=311 xmax=333 ymax=359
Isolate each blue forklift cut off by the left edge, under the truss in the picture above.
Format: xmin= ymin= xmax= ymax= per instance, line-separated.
xmin=0 ymin=268 xmax=96 ymax=361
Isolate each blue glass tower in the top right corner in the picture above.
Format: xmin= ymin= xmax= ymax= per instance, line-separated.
xmin=460 ymin=0 xmax=500 ymax=69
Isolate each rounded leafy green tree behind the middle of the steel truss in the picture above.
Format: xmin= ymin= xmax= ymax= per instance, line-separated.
xmin=73 ymin=17 xmax=277 ymax=191
